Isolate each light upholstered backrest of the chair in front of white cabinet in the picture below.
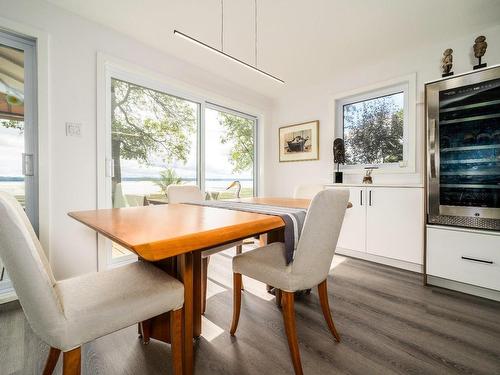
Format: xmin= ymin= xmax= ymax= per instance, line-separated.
xmin=291 ymin=189 xmax=349 ymax=286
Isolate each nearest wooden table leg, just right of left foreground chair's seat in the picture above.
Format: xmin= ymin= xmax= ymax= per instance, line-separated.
xmin=178 ymin=253 xmax=194 ymax=375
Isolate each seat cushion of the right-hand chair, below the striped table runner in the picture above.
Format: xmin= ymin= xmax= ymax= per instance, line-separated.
xmin=233 ymin=242 xmax=307 ymax=292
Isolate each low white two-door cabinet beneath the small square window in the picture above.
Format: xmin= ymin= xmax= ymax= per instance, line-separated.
xmin=327 ymin=186 xmax=424 ymax=265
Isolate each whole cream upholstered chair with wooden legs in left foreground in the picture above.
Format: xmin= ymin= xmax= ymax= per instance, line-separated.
xmin=0 ymin=192 xmax=184 ymax=375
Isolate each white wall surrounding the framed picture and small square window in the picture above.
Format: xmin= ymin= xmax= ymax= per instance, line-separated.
xmin=264 ymin=26 xmax=500 ymax=196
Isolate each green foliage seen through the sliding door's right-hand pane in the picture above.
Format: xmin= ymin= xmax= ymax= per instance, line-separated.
xmin=219 ymin=113 xmax=254 ymax=173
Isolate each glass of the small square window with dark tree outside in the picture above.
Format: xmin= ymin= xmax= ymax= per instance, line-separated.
xmin=344 ymin=97 xmax=404 ymax=164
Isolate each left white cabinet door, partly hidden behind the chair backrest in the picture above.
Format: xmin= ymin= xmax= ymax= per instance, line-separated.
xmin=333 ymin=187 xmax=367 ymax=252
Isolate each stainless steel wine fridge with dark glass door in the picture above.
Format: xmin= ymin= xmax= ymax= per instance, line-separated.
xmin=425 ymin=66 xmax=500 ymax=230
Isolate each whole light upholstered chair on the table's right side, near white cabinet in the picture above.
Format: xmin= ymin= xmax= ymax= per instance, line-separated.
xmin=231 ymin=189 xmax=349 ymax=374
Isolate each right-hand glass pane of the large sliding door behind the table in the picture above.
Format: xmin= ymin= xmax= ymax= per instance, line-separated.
xmin=204 ymin=104 xmax=257 ymax=199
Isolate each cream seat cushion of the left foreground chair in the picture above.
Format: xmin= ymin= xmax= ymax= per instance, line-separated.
xmin=55 ymin=261 xmax=184 ymax=351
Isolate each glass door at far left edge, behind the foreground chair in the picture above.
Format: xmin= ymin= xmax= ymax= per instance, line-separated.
xmin=0 ymin=32 xmax=38 ymax=294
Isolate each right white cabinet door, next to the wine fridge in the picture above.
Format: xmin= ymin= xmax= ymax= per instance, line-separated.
xmin=366 ymin=187 xmax=424 ymax=264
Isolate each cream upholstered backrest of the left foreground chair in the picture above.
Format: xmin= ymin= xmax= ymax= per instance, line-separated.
xmin=0 ymin=192 xmax=65 ymax=343
